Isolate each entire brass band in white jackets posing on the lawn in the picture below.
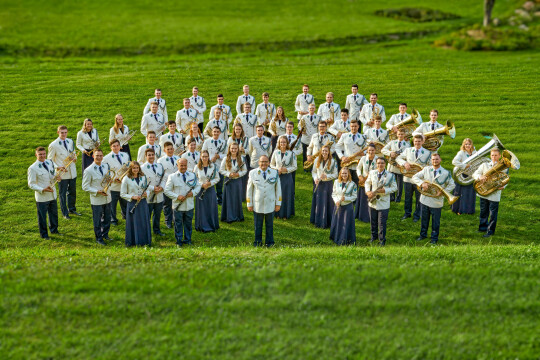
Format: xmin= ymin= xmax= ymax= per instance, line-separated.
xmin=28 ymin=84 xmax=510 ymax=246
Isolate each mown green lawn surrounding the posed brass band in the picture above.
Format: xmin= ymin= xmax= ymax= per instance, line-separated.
xmin=0 ymin=1 xmax=540 ymax=359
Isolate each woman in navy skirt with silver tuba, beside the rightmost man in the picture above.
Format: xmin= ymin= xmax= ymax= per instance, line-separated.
xmin=452 ymin=138 xmax=476 ymax=215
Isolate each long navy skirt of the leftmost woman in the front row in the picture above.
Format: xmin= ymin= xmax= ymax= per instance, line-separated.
xmin=126 ymin=198 xmax=152 ymax=246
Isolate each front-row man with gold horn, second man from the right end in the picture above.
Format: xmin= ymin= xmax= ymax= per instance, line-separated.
xmin=412 ymin=153 xmax=455 ymax=245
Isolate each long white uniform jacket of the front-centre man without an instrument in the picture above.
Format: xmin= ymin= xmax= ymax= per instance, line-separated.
xmin=246 ymin=167 xmax=281 ymax=214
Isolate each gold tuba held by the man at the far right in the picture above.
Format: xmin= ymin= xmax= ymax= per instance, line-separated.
xmin=474 ymin=150 xmax=520 ymax=196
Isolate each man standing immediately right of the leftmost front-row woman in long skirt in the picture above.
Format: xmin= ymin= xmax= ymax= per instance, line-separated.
xmin=142 ymin=149 xmax=167 ymax=236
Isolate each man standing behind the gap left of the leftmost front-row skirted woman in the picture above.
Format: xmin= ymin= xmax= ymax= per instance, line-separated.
xmin=103 ymin=139 xmax=129 ymax=226
